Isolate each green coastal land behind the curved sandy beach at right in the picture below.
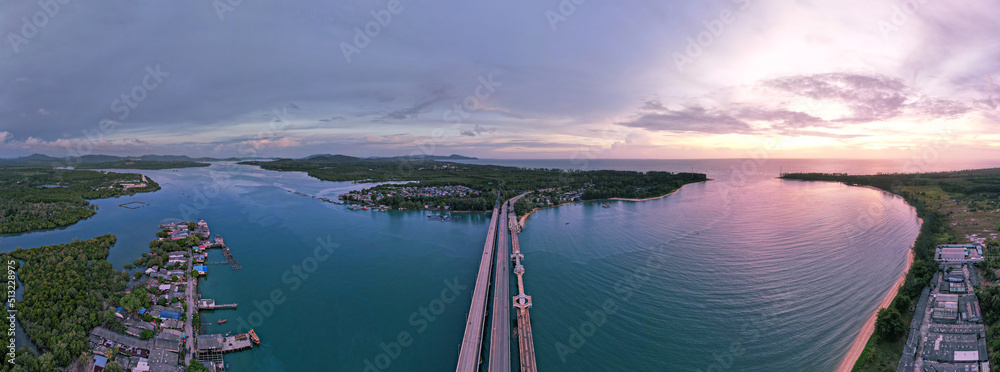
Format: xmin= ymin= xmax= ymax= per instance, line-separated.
xmin=780 ymin=168 xmax=1000 ymax=371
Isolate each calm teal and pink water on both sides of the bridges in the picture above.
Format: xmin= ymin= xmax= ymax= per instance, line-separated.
xmin=0 ymin=159 xmax=1000 ymax=371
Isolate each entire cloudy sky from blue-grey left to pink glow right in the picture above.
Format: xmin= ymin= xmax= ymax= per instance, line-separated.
xmin=0 ymin=0 xmax=1000 ymax=159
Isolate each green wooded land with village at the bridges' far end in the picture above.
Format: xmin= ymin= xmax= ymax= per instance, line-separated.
xmin=239 ymin=155 xmax=707 ymax=215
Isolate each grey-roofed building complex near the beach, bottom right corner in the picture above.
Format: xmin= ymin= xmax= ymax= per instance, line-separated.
xmin=896 ymin=244 xmax=990 ymax=372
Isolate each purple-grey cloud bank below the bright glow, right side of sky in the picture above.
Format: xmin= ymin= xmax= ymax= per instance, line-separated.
xmin=618 ymin=73 xmax=988 ymax=138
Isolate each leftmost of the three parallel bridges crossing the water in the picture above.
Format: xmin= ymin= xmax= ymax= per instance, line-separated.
xmin=455 ymin=201 xmax=500 ymax=372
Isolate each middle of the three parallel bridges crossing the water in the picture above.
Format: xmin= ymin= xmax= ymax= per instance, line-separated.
xmin=489 ymin=202 xmax=513 ymax=372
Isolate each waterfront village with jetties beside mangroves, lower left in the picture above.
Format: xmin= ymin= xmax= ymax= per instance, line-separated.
xmin=87 ymin=220 xmax=260 ymax=372
